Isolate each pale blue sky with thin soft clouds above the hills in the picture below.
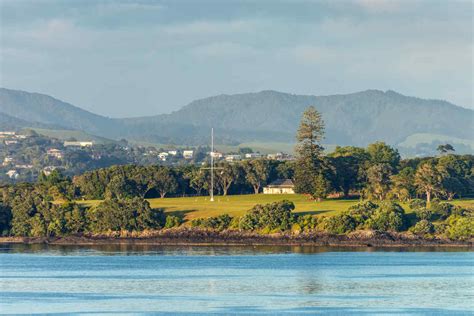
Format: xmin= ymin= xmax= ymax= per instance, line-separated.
xmin=0 ymin=0 xmax=474 ymax=117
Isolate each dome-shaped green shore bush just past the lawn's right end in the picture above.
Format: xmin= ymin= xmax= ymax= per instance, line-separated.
xmin=366 ymin=202 xmax=405 ymax=231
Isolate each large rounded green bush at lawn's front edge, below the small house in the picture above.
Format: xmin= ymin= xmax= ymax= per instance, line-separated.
xmin=239 ymin=200 xmax=295 ymax=232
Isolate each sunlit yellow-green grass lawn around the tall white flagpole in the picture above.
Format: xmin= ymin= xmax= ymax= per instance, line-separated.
xmin=81 ymin=194 xmax=474 ymax=220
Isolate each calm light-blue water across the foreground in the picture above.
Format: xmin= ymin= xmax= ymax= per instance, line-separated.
xmin=0 ymin=245 xmax=474 ymax=315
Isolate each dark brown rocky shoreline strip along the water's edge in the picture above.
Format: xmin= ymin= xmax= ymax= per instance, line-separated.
xmin=0 ymin=229 xmax=474 ymax=248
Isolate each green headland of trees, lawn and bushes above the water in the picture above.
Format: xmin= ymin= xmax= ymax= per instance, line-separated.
xmin=0 ymin=107 xmax=474 ymax=246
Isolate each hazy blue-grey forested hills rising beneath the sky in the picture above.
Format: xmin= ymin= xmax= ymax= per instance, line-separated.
xmin=0 ymin=89 xmax=474 ymax=146
